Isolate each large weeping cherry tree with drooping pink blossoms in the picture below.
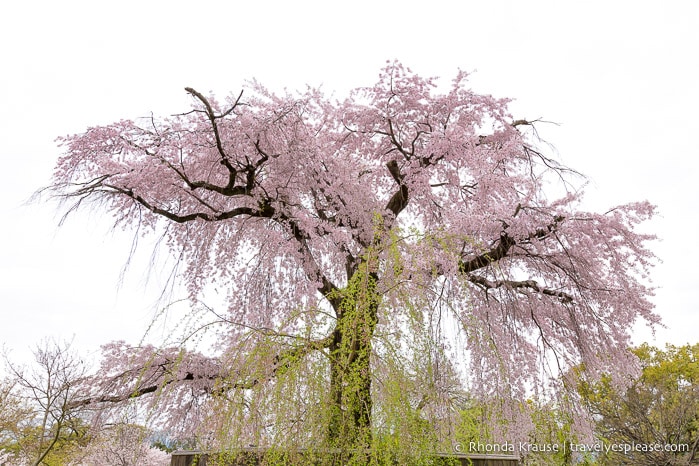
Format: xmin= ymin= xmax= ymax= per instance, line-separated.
xmin=52 ymin=63 xmax=657 ymax=464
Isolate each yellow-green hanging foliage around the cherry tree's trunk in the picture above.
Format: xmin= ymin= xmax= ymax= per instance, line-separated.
xmin=183 ymin=226 xmax=476 ymax=465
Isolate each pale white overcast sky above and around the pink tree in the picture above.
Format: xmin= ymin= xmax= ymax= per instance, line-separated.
xmin=0 ymin=0 xmax=699 ymax=368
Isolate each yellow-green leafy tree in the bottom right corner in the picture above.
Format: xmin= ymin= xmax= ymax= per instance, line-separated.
xmin=580 ymin=344 xmax=699 ymax=466
